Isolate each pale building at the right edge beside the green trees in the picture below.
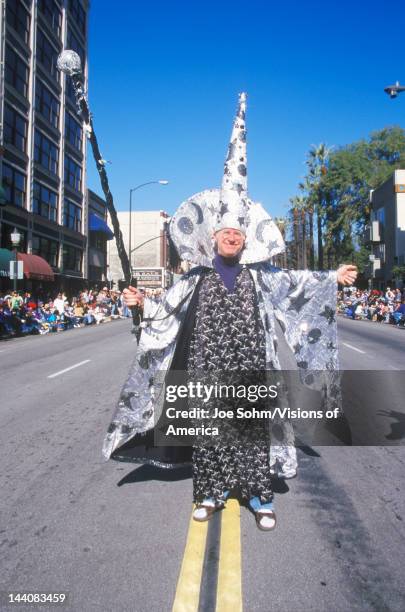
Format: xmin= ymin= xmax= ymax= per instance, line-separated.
xmin=367 ymin=170 xmax=405 ymax=289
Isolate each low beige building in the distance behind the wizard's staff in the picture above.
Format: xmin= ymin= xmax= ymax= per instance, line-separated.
xmin=107 ymin=210 xmax=172 ymax=288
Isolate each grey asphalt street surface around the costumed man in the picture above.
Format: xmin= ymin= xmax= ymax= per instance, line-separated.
xmin=0 ymin=320 xmax=405 ymax=612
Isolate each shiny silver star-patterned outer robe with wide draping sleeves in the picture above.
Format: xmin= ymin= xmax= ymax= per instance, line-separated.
xmin=103 ymin=262 xmax=340 ymax=478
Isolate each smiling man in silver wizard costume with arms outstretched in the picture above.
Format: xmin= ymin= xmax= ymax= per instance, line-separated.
xmin=103 ymin=94 xmax=356 ymax=530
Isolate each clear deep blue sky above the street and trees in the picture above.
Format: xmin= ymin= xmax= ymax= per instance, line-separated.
xmin=88 ymin=0 xmax=405 ymax=220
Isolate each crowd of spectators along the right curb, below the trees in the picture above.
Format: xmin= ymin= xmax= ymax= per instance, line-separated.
xmin=338 ymin=287 xmax=405 ymax=327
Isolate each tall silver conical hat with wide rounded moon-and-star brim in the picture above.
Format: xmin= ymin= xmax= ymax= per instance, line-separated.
xmin=170 ymin=93 xmax=285 ymax=267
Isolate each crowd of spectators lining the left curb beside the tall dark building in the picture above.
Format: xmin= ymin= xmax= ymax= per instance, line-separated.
xmin=0 ymin=287 xmax=131 ymax=339
